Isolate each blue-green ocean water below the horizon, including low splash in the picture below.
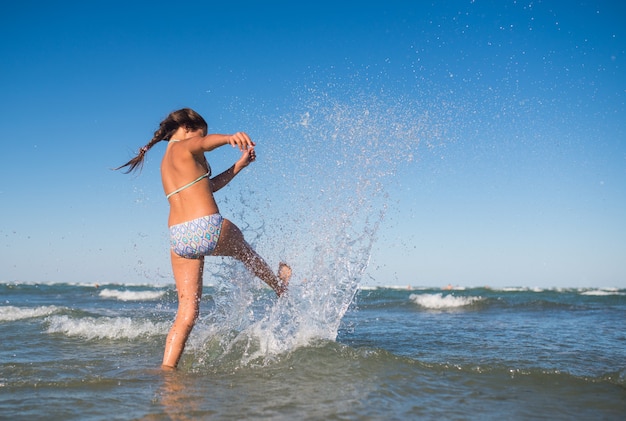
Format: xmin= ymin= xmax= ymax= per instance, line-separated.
xmin=0 ymin=278 xmax=626 ymax=420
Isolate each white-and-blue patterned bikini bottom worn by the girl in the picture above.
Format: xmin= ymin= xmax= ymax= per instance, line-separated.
xmin=170 ymin=213 xmax=224 ymax=259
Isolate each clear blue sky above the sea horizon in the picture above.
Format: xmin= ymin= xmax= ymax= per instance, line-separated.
xmin=0 ymin=0 xmax=626 ymax=288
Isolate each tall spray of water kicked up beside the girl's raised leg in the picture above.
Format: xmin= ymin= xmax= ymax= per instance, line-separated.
xmin=188 ymin=91 xmax=445 ymax=364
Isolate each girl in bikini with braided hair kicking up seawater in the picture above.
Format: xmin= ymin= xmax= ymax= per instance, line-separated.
xmin=117 ymin=108 xmax=291 ymax=369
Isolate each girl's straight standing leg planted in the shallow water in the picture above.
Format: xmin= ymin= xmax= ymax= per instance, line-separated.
xmin=162 ymin=251 xmax=204 ymax=369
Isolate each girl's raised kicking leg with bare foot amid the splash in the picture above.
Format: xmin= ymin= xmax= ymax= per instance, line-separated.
xmin=213 ymin=218 xmax=291 ymax=297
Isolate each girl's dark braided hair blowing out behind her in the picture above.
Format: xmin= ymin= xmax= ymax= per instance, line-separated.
xmin=115 ymin=108 xmax=208 ymax=174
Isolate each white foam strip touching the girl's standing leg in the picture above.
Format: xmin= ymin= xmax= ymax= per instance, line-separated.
xmin=47 ymin=316 xmax=170 ymax=339
